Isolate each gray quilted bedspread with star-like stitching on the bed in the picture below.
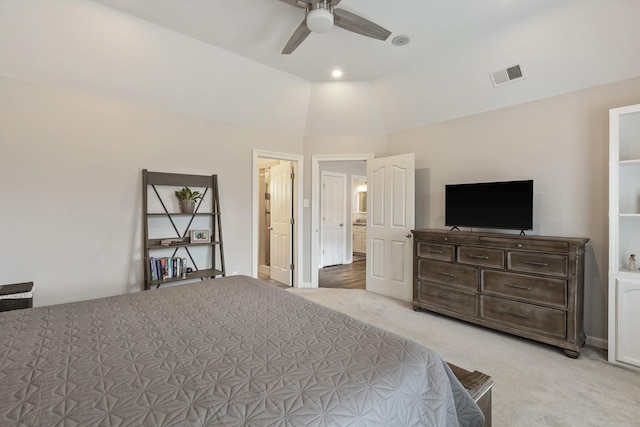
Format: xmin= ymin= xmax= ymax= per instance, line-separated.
xmin=0 ymin=276 xmax=484 ymax=426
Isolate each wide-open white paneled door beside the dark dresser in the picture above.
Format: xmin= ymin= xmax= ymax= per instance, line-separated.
xmin=366 ymin=153 xmax=415 ymax=301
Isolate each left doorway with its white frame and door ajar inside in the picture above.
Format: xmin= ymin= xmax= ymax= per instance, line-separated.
xmin=252 ymin=150 xmax=302 ymax=287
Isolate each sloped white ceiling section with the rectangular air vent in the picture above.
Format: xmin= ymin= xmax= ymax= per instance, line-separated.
xmin=372 ymin=0 xmax=640 ymax=133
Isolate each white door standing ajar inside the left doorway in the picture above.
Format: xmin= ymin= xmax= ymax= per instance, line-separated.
xmin=270 ymin=160 xmax=293 ymax=286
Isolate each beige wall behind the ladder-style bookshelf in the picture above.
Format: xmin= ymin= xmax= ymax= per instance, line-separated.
xmin=0 ymin=77 xmax=302 ymax=305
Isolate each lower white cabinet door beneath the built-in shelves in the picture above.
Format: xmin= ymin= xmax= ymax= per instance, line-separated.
xmin=616 ymin=278 xmax=640 ymax=366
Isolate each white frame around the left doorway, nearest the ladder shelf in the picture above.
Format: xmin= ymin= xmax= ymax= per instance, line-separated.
xmin=251 ymin=149 xmax=304 ymax=288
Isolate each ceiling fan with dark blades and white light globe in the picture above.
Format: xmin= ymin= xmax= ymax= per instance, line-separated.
xmin=280 ymin=0 xmax=391 ymax=55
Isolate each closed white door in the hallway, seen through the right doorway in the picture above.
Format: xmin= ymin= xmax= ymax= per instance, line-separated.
xmin=320 ymin=172 xmax=347 ymax=267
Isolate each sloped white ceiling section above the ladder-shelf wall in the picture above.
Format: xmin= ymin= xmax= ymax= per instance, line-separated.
xmin=0 ymin=0 xmax=312 ymax=136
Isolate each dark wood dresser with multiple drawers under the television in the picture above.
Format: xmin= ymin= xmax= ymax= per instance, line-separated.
xmin=413 ymin=229 xmax=589 ymax=358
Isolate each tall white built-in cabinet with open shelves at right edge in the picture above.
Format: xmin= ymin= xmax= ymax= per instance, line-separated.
xmin=609 ymin=104 xmax=640 ymax=366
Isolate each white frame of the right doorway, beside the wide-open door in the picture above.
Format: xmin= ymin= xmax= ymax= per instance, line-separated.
xmin=312 ymin=154 xmax=374 ymax=288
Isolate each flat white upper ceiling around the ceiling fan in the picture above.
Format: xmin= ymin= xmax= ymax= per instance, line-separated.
xmin=98 ymin=0 xmax=640 ymax=84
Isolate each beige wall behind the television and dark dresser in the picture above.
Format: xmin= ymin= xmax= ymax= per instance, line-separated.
xmin=388 ymin=78 xmax=640 ymax=344
